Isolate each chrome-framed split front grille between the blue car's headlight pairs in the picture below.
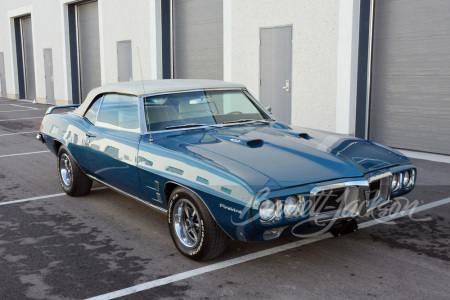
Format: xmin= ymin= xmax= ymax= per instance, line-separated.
xmin=309 ymin=172 xmax=392 ymax=226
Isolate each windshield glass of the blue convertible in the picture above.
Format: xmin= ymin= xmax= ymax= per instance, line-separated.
xmin=144 ymin=91 xmax=270 ymax=131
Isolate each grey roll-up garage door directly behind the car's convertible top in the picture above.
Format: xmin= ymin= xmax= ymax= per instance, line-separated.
xmin=173 ymin=0 xmax=223 ymax=79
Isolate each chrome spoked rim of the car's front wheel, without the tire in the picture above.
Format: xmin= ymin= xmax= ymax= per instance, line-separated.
xmin=172 ymin=199 xmax=202 ymax=248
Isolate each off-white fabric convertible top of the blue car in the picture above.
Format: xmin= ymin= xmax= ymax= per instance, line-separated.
xmin=74 ymin=79 xmax=245 ymax=116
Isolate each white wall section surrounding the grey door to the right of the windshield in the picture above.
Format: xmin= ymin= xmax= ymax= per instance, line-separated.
xmin=224 ymin=0 xmax=339 ymax=131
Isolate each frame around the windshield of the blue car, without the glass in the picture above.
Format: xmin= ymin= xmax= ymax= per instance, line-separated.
xmin=138 ymin=88 xmax=275 ymax=135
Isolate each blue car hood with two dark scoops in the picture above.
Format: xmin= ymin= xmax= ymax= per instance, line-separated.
xmin=156 ymin=123 xmax=409 ymax=188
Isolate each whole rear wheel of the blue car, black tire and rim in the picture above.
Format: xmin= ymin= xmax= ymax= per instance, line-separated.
xmin=57 ymin=146 xmax=92 ymax=197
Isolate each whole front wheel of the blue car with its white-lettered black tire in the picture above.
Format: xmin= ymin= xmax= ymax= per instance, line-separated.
xmin=167 ymin=187 xmax=229 ymax=261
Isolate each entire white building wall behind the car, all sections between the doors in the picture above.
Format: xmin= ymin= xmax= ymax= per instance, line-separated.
xmin=0 ymin=0 xmax=359 ymax=134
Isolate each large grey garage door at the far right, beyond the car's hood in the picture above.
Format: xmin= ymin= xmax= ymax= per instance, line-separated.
xmin=369 ymin=0 xmax=450 ymax=155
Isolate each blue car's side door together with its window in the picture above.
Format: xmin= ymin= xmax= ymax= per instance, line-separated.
xmin=85 ymin=94 xmax=141 ymax=196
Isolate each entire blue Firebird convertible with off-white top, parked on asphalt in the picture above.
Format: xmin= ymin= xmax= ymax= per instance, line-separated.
xmin=37 ymin=80 xmax=417 ymax=260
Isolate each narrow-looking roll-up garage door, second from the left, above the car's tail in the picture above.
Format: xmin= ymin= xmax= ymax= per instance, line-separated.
xmin=76 ymin=2 xmax=101 ymax=101
